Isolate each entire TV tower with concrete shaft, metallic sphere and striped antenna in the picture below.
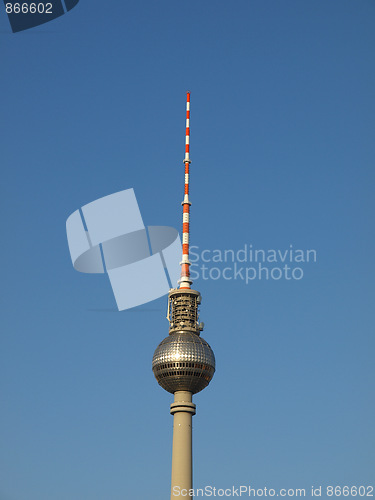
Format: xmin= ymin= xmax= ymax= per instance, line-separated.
xmin=152 ymin=92 xmax=215 ymax=500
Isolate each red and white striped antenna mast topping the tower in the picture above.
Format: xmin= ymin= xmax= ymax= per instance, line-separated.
xmin=179 ymin=92 xmax=193 ymax=289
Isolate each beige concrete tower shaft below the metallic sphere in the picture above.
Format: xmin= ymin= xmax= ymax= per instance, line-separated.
xmin=171 ymin=391 xmax=195 ymax=500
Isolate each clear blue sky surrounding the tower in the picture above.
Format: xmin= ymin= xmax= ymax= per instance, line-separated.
xmin=0 ymin=0 xmax=375 ymax=500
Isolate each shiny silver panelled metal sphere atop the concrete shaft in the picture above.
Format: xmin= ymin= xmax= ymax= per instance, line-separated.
xmin=152 ymin=331 xmax=215 ymax=394
